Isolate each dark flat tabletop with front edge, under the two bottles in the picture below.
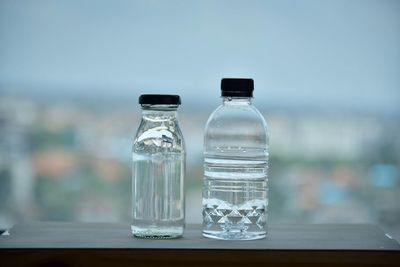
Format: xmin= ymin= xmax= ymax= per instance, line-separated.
xmin=0 ymin=222 xmax=400 ymax=266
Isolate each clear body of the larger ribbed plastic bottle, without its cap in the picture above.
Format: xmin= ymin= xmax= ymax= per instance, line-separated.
xmin=203 ymin=97 xmax=269 ymax=240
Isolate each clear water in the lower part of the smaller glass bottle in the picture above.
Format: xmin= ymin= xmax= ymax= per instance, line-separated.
xmin=131 ymin=153 xmax=185 ymax=238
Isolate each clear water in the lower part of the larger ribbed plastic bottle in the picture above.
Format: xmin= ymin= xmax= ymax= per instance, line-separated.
xmin=203 ymin=149 xmax=268 ymax=240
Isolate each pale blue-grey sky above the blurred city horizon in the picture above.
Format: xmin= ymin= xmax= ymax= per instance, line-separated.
xmin=0 ymin=0 xmax=400 ymax=111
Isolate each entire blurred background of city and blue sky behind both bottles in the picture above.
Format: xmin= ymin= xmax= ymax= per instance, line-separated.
xmin=0 ymin=0 xmax=400 ymax=240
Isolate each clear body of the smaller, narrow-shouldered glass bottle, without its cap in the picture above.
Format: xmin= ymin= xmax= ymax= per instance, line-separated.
xmin=131 ymin=105 xmax=185 ymax=238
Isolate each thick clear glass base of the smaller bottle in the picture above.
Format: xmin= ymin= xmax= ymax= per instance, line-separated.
xmin=131 ymin=225 xmax=183 ymax=239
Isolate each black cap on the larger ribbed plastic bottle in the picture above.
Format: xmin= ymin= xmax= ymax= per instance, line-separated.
xmin=221 ymin=78 xmax=254 ymax=97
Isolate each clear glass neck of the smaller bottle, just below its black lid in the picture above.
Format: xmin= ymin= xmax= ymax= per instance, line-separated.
xmin=142 ymin=105 xmax=178 ymax=122
